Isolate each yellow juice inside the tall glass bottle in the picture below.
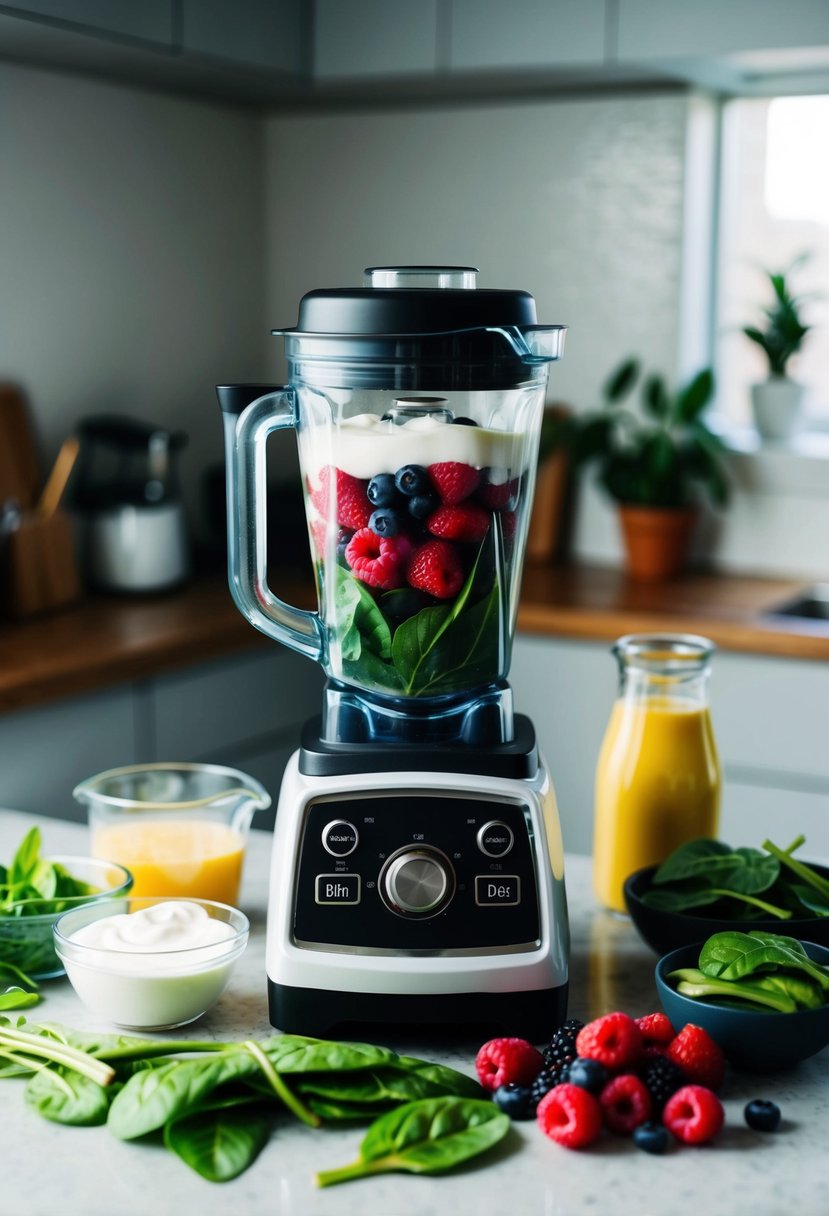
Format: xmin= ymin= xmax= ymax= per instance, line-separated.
xmin=593 ymin=697 xmax=721 ymax=912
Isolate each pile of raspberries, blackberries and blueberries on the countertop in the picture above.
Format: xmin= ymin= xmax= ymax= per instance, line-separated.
xmin=475 ymin=1012 xmax=780 ymax=1153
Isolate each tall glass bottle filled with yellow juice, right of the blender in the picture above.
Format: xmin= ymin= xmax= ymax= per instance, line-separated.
xmin=593 ymin=634 xmax=722 ymax=912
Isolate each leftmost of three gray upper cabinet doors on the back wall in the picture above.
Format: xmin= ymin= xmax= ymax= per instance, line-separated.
xmin=314 ymin=0 xmax=439 ymax=83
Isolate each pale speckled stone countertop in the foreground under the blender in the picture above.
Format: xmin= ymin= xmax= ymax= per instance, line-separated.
xmin=0 ymin=811 xmax=829 ymax=1216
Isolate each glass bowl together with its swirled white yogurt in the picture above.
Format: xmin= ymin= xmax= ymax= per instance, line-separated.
xmin=53 ymin=897 xmax=250 ymax=1030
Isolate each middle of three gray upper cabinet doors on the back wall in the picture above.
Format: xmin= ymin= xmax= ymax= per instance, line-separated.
xmin=450 ymin=0 xmax=605 ymax=71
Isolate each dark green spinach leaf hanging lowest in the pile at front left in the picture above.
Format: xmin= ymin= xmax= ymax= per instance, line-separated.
xmin=164 ymin=1104 xmax=271 ymax=1182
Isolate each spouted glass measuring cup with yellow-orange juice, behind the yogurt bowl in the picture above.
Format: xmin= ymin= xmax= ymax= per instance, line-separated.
xmin=73 ymin=762 xmax=271 ymax=905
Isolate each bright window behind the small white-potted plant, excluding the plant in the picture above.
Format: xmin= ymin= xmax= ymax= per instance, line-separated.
xmin=716 ymin=96 xmax=829 ymax=430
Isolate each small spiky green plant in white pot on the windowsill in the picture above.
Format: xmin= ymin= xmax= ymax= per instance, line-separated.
xmin=743 ymin=257 xmax=811 ymax=439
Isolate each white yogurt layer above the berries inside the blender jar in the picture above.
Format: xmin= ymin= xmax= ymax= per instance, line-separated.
xmin=299 ymin=413 xmax=529 ymax=486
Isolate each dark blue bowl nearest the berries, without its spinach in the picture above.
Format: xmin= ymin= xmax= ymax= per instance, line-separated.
xmin=655 ymin=941 xmax=829 ymax=1073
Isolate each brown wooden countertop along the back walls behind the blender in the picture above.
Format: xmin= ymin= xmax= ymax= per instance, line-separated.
xmin=0 ymin=564 xmax=829 ymax=715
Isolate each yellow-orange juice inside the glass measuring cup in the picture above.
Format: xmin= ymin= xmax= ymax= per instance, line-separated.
xmin=92 ymin=818 xmax=244 ymax=905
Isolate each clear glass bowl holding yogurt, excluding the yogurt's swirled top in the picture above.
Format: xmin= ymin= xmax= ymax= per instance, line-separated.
xmin=53 ymin=896 xmax=250 ymax=1030
